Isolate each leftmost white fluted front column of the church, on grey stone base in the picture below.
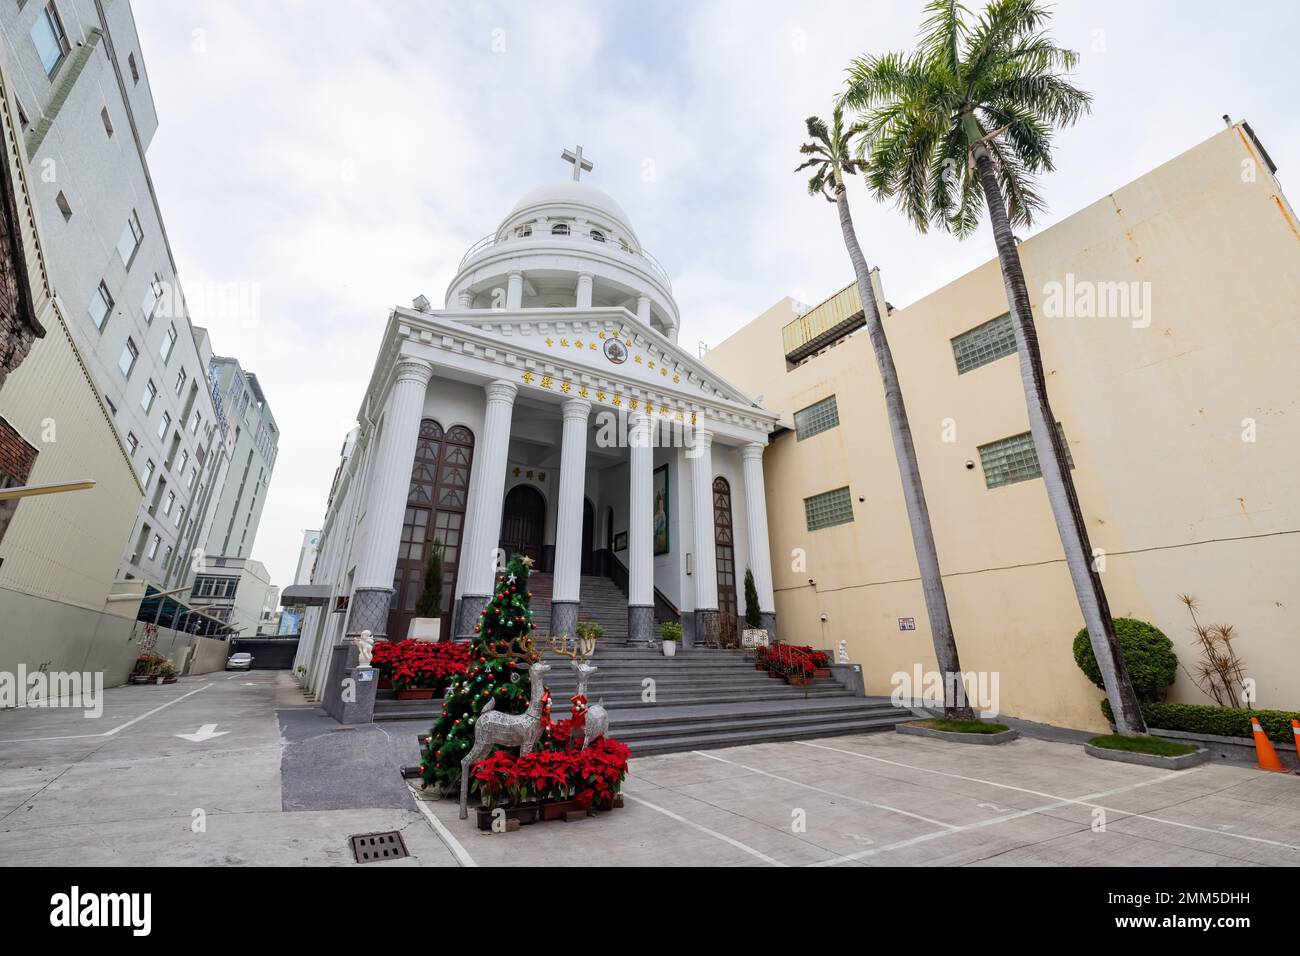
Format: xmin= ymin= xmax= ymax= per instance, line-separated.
xmin=347 ymin=358 xmax=433 ymax=636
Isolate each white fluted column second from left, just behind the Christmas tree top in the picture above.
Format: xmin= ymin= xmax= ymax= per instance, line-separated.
xmin=458 ymin=378 xmax=519 ymax=608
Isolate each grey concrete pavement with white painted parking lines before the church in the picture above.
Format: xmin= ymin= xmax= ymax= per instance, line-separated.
xmin=0 ymin=671 xmax=1300 ymax=866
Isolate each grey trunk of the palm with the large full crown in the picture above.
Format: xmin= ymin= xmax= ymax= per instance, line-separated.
xmin=971 ymin=142 xmax=1147 ymax=736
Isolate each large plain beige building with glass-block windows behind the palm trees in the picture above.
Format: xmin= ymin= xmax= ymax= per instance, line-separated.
xmin=706 ymin=124 xmax=1300 ymax=728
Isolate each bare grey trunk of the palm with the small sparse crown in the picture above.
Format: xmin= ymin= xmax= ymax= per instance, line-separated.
xmin=835 ymin=182 xmax=975 ymax=719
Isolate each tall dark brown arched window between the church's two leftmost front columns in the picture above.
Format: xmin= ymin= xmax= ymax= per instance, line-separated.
xmin=389 ymin=419 xmax=475 ymax=640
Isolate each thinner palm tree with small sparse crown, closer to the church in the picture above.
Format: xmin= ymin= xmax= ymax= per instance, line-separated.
xmin=794 ymin=105 xmax=975 ymax=719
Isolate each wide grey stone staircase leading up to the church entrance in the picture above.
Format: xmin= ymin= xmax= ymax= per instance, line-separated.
xmin=374 ymin=587 xmax=913 ymax=756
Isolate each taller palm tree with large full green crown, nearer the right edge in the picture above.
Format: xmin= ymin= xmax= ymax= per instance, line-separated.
xmin=842 ymin=0 xmax=1147 ymax=735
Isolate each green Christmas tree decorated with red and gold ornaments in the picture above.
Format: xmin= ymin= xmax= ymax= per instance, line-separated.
xmin=420 ymin=554 xmax=536 ymax=791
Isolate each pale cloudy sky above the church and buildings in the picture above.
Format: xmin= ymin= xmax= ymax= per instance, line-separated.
xmin=133 ymin=0 xmax=1300 ymax=584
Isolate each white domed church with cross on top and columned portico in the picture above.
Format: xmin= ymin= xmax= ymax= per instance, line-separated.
xmin=286 ymin=148 xmax=777 ymax=695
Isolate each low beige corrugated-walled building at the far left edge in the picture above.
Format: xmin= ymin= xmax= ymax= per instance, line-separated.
xmin=0 ymin=41 xmax=144 ymax=683
